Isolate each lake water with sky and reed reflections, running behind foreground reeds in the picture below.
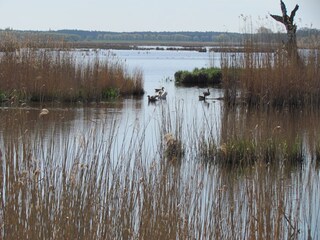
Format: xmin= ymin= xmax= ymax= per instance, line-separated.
xmin=0 ymin=48 xmax=320 ymax=239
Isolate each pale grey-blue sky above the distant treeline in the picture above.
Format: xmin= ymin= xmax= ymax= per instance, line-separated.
xmin=0 ymin=0 xmax=320 ymax=32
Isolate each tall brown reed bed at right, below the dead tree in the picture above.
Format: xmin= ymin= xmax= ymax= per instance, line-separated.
xmin=222 ymin=41 xmax=320 ymax=108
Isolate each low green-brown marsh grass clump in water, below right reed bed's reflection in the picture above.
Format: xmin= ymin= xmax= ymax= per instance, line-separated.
xmin=202 ymin=136 xmax=305 ymax=169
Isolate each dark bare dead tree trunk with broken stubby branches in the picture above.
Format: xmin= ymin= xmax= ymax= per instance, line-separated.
xmin=270 ymin=0 xmax=300 ymax=62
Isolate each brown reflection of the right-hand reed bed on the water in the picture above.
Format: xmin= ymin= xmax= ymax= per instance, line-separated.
xmin=221 ymin=107 xmax=320 ymax=146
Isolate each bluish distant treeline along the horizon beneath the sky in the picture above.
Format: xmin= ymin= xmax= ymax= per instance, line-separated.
xmin=0 ymin=27 xmax=320 ymax=44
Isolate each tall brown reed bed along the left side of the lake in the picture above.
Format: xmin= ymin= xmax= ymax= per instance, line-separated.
xmin=0 ymin=31 xmax=144 ymax=102
